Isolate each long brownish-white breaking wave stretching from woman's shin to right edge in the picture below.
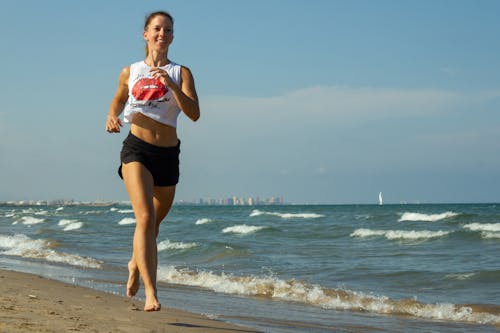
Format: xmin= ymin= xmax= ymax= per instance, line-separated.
xmin=158 ymin=266 xmax=500 ymax=324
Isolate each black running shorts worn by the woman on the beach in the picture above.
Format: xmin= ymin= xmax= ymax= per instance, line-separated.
xmin=118 ymin=133 xmax=181 ymax=186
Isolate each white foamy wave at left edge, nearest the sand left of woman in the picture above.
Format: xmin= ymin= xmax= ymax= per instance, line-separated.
xmin=0 ymin=234 xmax=102 ymax=268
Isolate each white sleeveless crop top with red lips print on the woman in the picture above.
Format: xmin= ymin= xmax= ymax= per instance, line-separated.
xmin=123 ymin=61 xmax=181 ymax=127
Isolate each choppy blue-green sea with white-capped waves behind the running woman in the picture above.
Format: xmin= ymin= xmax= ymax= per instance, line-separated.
xmin=0 ymin=204 xmax=500 ymax=332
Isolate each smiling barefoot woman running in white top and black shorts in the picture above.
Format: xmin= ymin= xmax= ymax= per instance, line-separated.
xmin=106 ymin=12 xmax=200 ymax=311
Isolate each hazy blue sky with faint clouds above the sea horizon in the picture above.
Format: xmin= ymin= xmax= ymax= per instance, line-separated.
xmin=0 ymin=0 xmax=500 ymax=204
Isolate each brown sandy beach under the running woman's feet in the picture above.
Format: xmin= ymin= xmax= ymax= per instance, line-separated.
xmin=0 ymin=270 xmax=256 ymax=333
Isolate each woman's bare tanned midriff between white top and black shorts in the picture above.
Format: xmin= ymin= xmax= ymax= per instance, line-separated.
xmin=130 ymin=113 xmax=178 ymax=147
